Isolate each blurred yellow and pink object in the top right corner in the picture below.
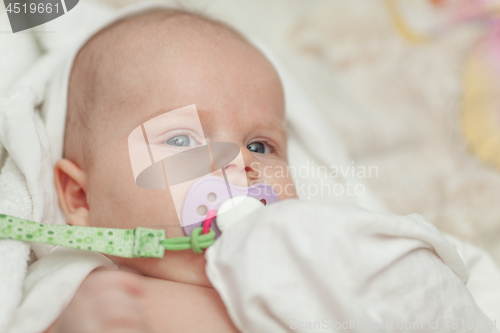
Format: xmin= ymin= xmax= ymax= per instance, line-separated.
xmin=384 ymin=0 xmax=500 ymax=168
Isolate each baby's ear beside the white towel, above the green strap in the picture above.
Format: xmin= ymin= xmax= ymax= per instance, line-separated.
xmin=54 ymin=158 xmax=89 ymax=226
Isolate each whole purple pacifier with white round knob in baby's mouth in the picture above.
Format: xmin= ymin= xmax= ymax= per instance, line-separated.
xmin=182 ymin=177 xmax=279 ymax=238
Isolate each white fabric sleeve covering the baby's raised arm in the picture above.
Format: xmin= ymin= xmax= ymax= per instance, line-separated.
xmin=206 ymin=200 xmax=497 ymax=333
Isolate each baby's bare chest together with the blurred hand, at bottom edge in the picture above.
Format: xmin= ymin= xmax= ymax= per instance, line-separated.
xmin=45 ymin=271 xmax=238 ymax=333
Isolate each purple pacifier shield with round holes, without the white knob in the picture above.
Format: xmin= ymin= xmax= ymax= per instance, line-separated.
xmin=182 ymin=177 xmax=279 ymax=238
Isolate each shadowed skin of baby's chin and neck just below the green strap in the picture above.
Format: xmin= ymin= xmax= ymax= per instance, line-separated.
xmin=108 ymin=250 xmax=212 ymax=288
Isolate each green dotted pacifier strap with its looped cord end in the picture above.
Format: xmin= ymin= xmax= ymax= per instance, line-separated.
xmin=0 ymin=214 xmax=215 ymax=258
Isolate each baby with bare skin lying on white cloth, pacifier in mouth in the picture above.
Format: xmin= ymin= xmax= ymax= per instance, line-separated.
xmin=47 ymin=9 xmax=296 ymax=332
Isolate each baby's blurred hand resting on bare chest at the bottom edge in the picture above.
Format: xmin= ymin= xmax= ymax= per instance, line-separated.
xmin=47 ymin=270 xmax=149 ymax=333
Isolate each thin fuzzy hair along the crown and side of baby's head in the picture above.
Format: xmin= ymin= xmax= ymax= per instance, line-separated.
xmin=63 ymin=8 xmax=248 ymax=170
